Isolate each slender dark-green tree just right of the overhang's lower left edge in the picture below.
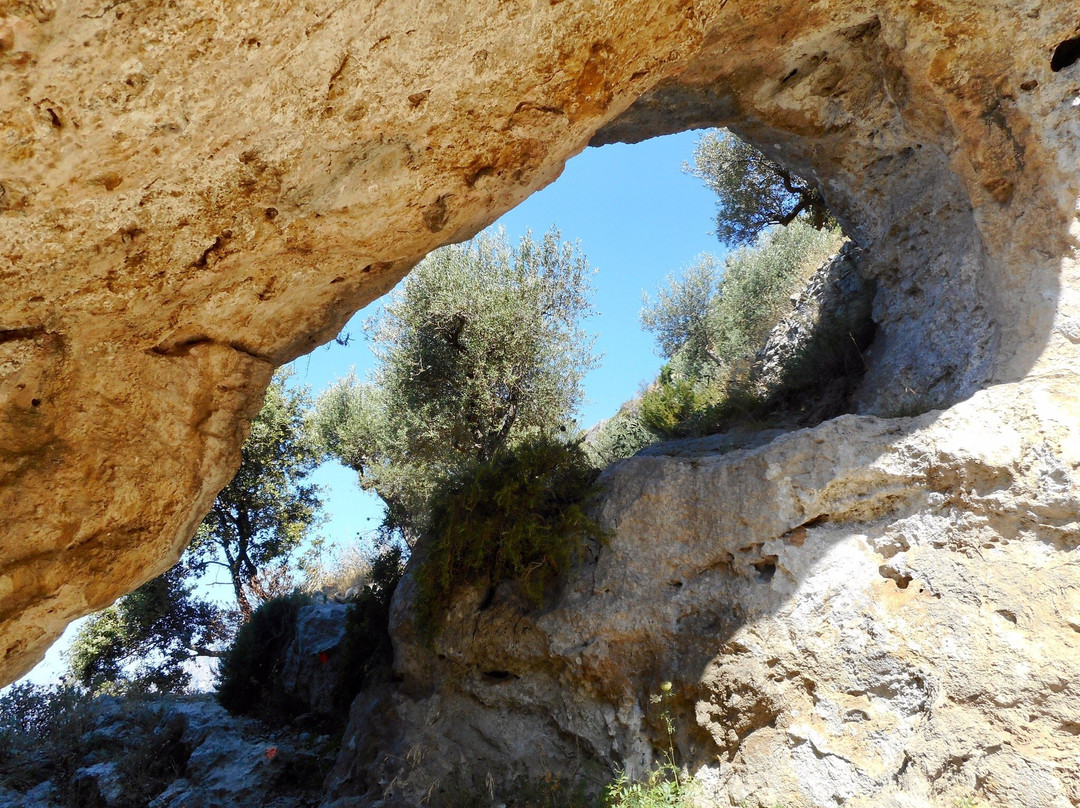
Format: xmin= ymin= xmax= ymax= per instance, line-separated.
xmin=189 ymin=372 xmax=322 ymax=620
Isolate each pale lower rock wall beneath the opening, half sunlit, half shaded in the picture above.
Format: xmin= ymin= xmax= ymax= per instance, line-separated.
xmin=326 ymin=381 xmax=1080 ymax=808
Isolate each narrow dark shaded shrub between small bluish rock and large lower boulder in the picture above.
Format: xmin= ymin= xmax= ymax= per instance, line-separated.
xmin=338 ymin=546 xmax=404 ymax=714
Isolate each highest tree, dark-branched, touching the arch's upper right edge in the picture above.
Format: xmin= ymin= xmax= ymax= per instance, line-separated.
xmin=685 ymin=130 xmax=836 ymax=245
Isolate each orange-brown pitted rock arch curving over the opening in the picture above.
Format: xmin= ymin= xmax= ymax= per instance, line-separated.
xmin=0 ymin=0 xmax=1080 ymax=699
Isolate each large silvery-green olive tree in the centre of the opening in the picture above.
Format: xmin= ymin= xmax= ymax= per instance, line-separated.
xmin=311 ymin=229 xmax=596 ymax=542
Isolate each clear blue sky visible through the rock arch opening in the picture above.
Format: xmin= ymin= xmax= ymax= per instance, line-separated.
xmin=14 ymin=132 xmax=724 ymax=683
